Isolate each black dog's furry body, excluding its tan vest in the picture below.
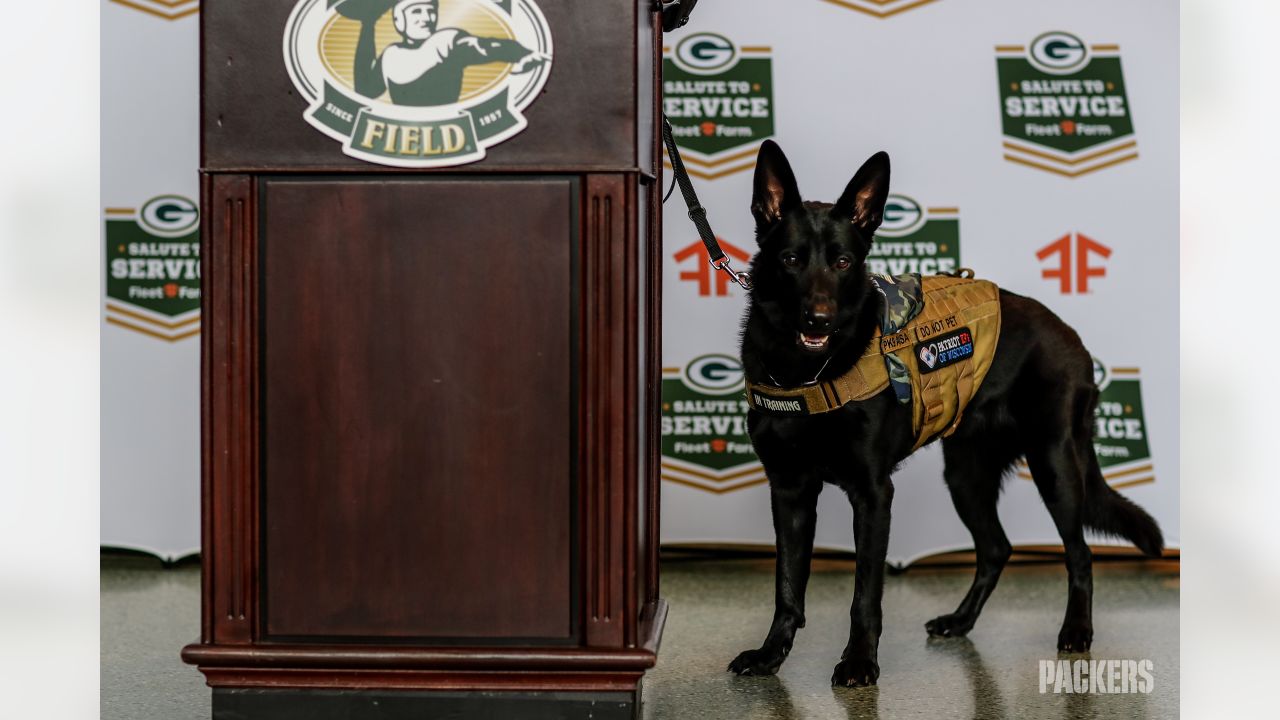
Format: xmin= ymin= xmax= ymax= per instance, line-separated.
xmin=728 ymin=141 xmax=1164 ymax=685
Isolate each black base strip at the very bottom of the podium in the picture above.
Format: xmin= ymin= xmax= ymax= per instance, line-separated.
xmin=214 ymin=688 xmax=640 ymax=720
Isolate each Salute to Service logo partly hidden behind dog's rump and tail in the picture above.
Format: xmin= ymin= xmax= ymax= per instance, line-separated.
xmin=1018 ymin=359 xmax=1156 ymax=488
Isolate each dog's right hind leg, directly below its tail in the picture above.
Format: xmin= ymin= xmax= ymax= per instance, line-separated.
xmin=1027 ymin=424 xmax=1093 ymax=652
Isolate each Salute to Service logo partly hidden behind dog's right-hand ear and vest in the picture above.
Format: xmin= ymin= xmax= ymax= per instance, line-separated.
xmin=867 ymin=195 xmax=960 ymax=275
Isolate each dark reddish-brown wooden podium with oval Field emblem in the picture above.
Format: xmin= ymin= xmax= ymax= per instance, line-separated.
xmin=182 ymin=0 xmax=666 ymax=720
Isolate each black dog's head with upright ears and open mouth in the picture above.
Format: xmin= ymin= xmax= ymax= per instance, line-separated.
xmin=751 ymin=140 xmax=888 ymax=355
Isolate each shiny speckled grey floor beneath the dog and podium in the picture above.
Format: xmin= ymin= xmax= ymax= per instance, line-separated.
xmin=101 ymin=545 xmax=1179 ymax=720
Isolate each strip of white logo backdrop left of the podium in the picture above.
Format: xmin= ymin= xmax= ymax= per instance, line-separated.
xmin=101 ymin=0 xmax=200 ymax=560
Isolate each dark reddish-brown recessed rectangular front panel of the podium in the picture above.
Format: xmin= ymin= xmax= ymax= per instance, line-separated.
xmin=260 ymin=177 xmax=579 ymax=643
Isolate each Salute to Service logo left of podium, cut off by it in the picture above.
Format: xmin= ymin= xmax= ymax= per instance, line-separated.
xmin=105 ymin=195 xmax=200 ymax=342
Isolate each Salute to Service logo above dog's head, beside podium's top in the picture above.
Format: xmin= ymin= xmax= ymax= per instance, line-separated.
xmin=662 ymin=32 xmax=773 ymax=179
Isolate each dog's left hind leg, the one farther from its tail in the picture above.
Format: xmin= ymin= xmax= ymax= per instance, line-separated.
xmin=924 ymin=437 xmax=1012 ymax=637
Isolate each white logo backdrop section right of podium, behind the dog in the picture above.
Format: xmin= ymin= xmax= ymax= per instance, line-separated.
xmin=662 ymin=0 xmax=1179 ymax=565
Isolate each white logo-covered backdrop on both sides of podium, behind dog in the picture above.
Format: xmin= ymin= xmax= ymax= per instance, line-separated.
xmin=101 ymin=0 xmax=1179 ymax=562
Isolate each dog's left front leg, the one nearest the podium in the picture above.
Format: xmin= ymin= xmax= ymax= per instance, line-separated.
xmin=728 ymin=478 xmax=822 ymax=675
